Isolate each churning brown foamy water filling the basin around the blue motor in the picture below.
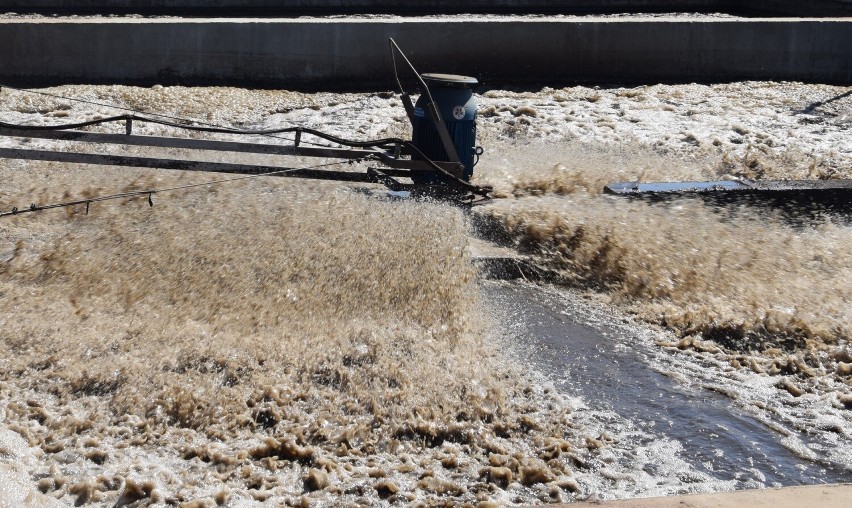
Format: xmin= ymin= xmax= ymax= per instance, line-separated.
xmin=0 ymin=83 xmax=852 ymax=506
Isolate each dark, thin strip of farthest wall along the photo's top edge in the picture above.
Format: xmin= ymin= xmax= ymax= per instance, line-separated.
xmin=0 ymin=0 xmax=852 ymax=16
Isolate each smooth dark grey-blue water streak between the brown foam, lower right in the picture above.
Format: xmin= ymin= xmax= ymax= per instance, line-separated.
xmin=481 ymin=281 xmax=849 ymax=488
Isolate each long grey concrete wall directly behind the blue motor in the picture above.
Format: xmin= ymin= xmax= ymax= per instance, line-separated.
xmin=0 ymin=18 xmax=852 ymax=90
